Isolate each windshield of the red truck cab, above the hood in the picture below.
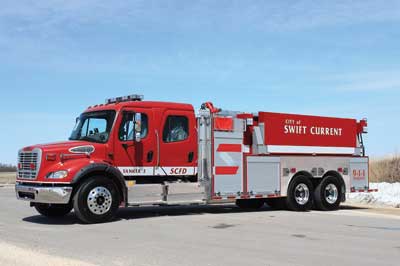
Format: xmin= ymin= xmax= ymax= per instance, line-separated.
xmin=69 ymin=110 xmax=115 ymax=143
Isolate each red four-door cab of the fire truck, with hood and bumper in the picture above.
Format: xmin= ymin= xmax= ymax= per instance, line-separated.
xmin=16 ymin=95 xmax=197 ymax=222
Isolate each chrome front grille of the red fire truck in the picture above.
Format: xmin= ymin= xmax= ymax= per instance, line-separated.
xmin=18 ymin=151 xmax=40 ymax=179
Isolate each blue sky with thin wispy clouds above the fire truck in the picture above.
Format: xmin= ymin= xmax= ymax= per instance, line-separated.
xmin=0 ymin=0 xmax=400 ymax=163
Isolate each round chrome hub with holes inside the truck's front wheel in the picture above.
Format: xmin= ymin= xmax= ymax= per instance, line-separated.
xmin=87 ymin=187 xmax=112 ymax=215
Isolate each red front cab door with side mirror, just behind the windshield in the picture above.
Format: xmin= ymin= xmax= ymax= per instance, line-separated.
xmin=114 ymin=108 xmax=156 ymax=176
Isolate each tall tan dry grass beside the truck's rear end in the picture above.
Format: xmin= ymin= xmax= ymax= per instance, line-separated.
xmin=370 ymin=155 xmax=400 ymax=183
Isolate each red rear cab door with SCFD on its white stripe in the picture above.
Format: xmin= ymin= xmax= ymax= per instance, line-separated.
xmin=155 ymin=110 xmax=197 ymax=176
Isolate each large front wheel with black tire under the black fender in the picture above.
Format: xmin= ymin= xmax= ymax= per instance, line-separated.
xmin=74 ymin=176 xmax=120 ymax=224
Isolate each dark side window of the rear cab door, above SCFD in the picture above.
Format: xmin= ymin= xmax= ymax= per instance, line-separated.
xmin=163 ymin=116 xmax=189 ymax=143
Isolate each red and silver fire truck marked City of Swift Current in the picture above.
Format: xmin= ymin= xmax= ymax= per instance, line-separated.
xmin=15 ymin=95 xmax=372 ymax=223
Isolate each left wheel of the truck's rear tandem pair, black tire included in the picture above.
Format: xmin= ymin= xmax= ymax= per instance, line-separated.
xmin=286 ymin=175 xmax=313 ymax=211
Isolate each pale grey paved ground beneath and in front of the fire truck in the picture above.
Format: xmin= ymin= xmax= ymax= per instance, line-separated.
xmin=0 ymin=187 xmax=400 ymax=266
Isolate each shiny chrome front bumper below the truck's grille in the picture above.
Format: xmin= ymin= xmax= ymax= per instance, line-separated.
xmin=15 ymin=184 xmax=72 ymax=204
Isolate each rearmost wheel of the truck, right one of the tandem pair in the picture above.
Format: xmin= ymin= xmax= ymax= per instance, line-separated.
xmin=314 ymin=176 xmax=342 ymax=211
